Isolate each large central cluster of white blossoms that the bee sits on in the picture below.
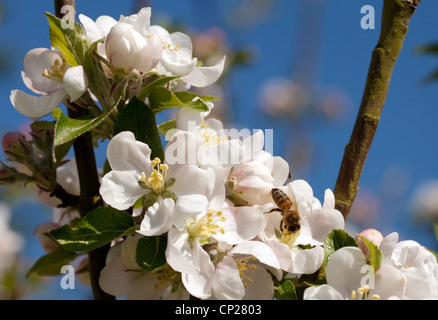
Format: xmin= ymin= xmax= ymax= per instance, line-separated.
xmin=100 ymin=109 xmax=344 ymax=299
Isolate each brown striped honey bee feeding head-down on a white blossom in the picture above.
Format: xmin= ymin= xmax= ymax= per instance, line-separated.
xmin=269 ymin=188 xmax=301 ymax=234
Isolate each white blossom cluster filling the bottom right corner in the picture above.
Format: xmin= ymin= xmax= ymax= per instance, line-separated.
xmin=304 ymin=229 xmax=438 ymax=300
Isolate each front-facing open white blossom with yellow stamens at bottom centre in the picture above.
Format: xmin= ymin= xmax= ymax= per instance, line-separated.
xmin=166 ymin=194 xmax=266 ymax=299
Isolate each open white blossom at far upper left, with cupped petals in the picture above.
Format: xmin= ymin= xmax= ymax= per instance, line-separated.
xmin=10 ymin=48 xmax=88 ymax=119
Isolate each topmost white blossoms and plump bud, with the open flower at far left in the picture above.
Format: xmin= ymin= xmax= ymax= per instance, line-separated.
xmin=10 ymin=8 xmax=225 ymax=119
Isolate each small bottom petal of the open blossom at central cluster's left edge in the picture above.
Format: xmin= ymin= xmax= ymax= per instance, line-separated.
xmin=138 ymin=197 xmax=175 ymax=236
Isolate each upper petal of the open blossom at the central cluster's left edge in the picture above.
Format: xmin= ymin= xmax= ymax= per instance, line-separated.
xmin=107 ymin=131 xmax=152 ymax=175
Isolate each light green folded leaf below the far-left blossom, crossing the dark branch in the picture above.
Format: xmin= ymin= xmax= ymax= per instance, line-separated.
xmin=54 ymin=102 xmax=118 ymax=146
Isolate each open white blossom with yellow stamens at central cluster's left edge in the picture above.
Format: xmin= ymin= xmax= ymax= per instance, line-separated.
xmin=100 ymin=131 xmax=215 ymax=235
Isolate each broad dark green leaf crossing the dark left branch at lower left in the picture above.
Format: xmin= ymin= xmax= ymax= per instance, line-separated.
xmin=49 ymin=207 xmax=135 ymax=252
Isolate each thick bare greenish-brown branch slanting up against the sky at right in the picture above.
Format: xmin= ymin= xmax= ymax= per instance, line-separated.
xmin=334 ymin=0 xmax=421 ymax=220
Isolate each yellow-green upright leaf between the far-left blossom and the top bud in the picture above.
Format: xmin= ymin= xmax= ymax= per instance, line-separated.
xmin=46 ymin=12 xmax=90 ymax=67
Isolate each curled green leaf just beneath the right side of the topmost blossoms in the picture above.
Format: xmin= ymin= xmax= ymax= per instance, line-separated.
xmin=149 ymin=87 xmax=210 ymax=114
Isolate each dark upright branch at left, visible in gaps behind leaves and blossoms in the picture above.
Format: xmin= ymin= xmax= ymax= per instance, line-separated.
xmin=55 ymin=0 xmax=115 ymax=300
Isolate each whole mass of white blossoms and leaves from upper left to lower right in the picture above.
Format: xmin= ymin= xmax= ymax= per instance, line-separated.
xmin=0 ymin=8 xmax=438 ymax=299
